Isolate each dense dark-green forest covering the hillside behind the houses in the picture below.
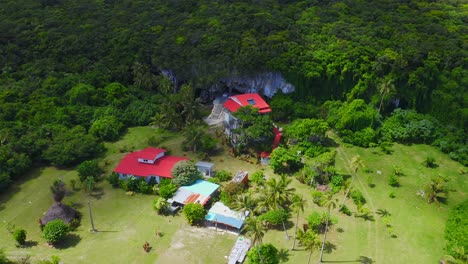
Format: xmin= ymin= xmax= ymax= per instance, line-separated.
xmin=0 ymin=0 xmax=468 ymax=190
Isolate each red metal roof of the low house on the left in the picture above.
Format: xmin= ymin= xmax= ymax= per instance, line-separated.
xmin=114 ymin=149 xmax=188 ymax=178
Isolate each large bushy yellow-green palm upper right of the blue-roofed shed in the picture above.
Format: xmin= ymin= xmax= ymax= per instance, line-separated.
xmin=266 ymin=174 xmax=296 ymax=240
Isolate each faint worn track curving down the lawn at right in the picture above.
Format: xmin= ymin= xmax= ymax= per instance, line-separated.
xmin=336 ymin=148 xmax=380 ymax=263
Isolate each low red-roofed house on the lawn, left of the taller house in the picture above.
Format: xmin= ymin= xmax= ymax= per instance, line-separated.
xmin=114 ymin=148 xmax=188 ymax=183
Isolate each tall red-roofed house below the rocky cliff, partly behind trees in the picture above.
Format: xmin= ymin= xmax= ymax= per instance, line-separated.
xmin=223 ymin=93 xmax=271 ymax=141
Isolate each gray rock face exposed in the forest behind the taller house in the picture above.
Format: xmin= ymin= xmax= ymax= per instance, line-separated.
xmin=221 ymin=72 xmax=295 ymax=98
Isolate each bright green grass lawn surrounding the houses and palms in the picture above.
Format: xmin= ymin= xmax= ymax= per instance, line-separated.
xmin=0 ymin=127 xmax=467 ymax=264
